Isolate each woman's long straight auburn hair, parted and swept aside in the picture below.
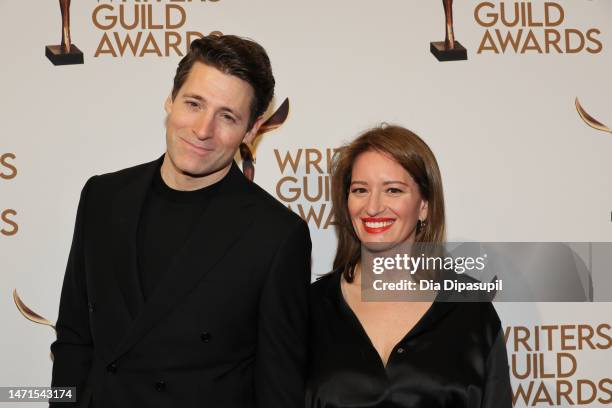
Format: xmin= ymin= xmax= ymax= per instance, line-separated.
xmin=331 ymin=125 xmax=446 ymax=282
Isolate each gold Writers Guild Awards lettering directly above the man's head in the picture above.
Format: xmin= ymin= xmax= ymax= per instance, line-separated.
xmin=91 ymin=0 xmax=221 ymax=58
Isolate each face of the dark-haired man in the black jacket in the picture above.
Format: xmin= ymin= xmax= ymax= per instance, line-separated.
xmin=164 ymin=62 xmax=262 ymax=184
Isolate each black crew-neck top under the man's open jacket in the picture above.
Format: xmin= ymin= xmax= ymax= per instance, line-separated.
xmin=138 ymin=169 xmax=225 ymax=301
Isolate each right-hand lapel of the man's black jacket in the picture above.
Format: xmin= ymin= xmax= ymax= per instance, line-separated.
xmin=116 ymin=163 xmax=254 ymax=357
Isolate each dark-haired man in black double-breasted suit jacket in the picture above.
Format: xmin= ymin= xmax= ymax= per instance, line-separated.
xmin=51 ymin=35 xmax=311 ymax=408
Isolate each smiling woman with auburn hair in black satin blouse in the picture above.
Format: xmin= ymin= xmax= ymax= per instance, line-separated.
xmin=306 ymin=126 xmax=512 ymax=408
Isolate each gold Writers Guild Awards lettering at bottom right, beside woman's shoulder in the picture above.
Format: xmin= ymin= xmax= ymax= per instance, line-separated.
xmin=504 ymin=322 xmax=612 ymax=407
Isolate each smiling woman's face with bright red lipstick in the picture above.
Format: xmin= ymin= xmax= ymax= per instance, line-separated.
xmin=348 ymin=151 xmax=427 ymax=243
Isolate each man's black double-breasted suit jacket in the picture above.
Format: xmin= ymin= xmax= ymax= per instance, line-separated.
xmin=51 ymin=159 xmax=311 ymax=408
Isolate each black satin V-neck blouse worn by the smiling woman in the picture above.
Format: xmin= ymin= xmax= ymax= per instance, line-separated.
xmin=306 ymin=272 xmax=512 ymax=408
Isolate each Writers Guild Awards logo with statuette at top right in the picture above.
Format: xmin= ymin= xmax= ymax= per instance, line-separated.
xmin=430 ymin=0 xmax=604 ymax=61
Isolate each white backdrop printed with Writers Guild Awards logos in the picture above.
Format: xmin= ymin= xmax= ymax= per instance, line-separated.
xmin=0 ymin=0 xmax=612 ymax=407
